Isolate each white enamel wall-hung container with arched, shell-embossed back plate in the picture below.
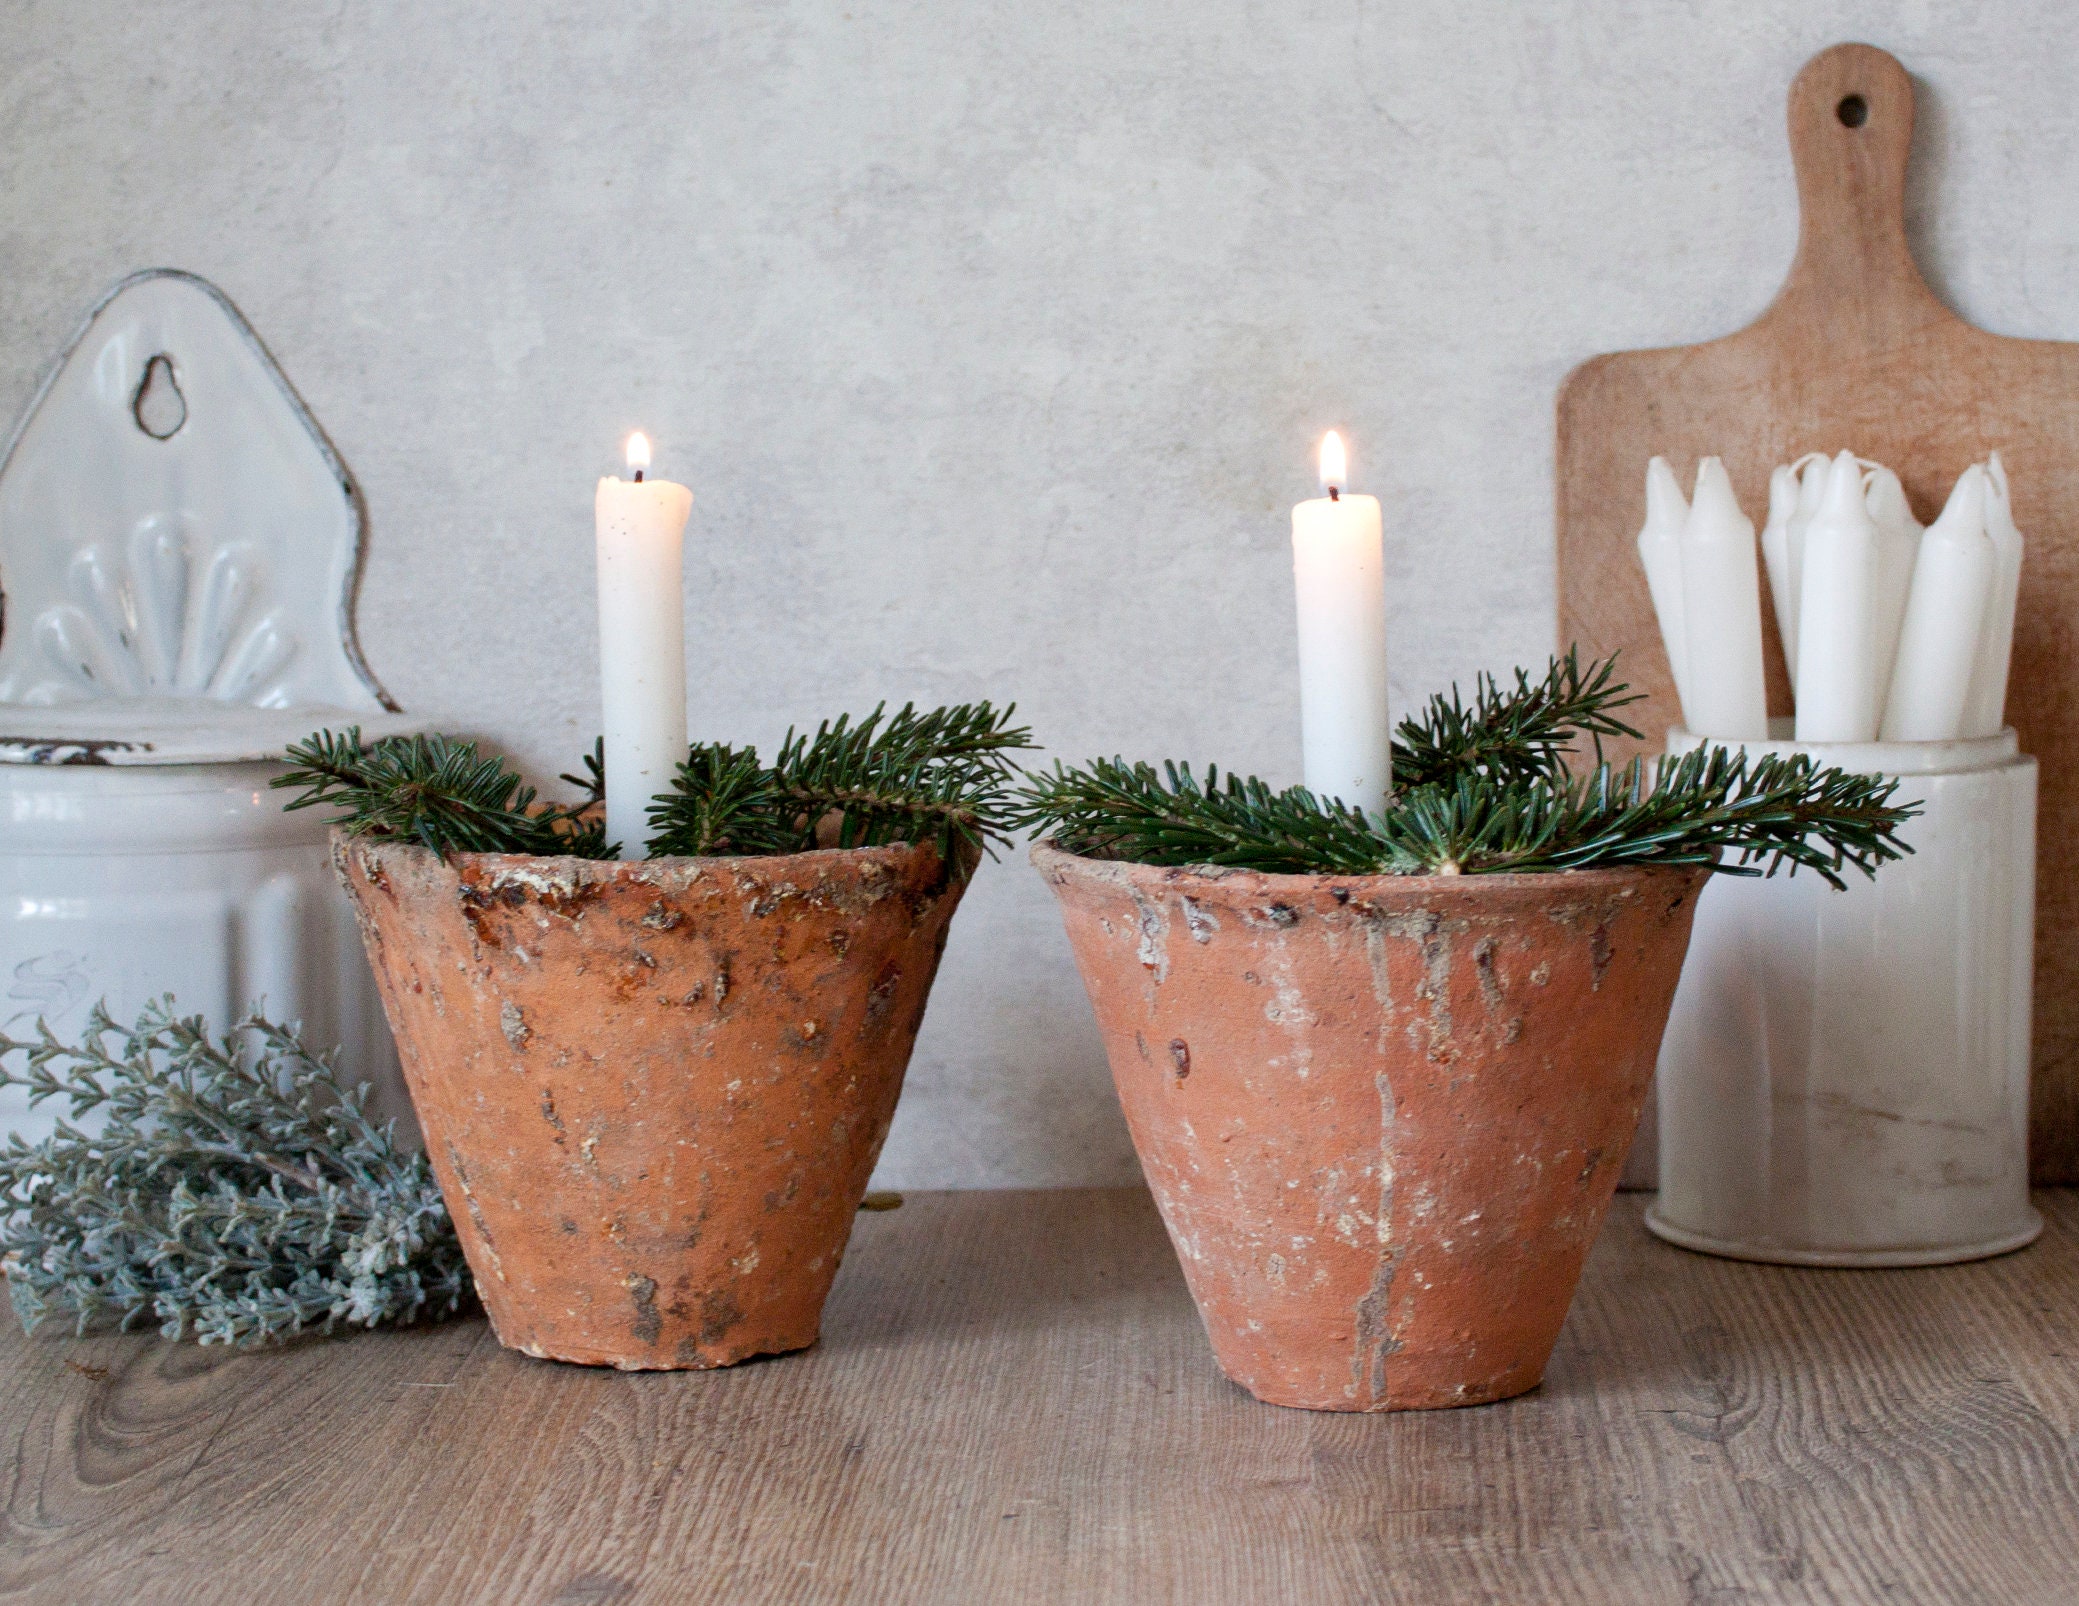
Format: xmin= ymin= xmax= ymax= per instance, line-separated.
xmin=0 ymin=270 xmax=412 ymax=1138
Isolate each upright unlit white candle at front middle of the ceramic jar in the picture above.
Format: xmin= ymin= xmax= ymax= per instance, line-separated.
xmin=1796 ymin=451 xmax=1884 ymax=743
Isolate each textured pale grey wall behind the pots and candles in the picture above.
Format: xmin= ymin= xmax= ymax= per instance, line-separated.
xmin=0 ymin=0 xmax=2079 ymax=1186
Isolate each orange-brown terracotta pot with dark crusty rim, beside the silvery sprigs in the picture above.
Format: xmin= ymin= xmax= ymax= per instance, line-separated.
xmin=333 ymin=836 xmax=965 ymax=1369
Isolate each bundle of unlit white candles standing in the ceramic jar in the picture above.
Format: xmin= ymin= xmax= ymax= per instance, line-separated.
xmin=1638 ymin=451 xmax=2021 ymax=743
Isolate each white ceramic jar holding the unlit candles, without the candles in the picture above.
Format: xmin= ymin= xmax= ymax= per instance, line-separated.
xmin=1647 ymin=728 xmax=2042 ymax=1265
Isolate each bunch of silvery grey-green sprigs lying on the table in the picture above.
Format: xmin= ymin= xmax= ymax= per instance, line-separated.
xmin=0 ymin=999 xmax=472 ymax=1344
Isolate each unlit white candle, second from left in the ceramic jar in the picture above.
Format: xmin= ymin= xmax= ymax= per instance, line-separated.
xmin=1682 ymin=458 xmax=1769 ymax=741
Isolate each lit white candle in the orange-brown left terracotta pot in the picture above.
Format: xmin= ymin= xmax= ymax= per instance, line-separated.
xmin=593 ymin=435 xmax=692 ymax=859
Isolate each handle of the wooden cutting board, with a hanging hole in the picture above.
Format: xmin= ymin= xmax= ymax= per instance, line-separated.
xmin=1769 ymin=44 xmax=1952 ymax=328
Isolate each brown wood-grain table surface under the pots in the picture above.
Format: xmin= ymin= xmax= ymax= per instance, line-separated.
xmin=0 ymin=1192 xmax=2079 ymax=1606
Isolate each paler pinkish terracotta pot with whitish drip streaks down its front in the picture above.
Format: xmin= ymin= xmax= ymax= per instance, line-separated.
xmin=1033 ymin=845 xmax=1707 ymax=1410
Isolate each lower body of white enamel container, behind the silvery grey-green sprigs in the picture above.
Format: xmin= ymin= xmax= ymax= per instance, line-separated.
xmin=0 ymin=763 xmax=416 ymax=1140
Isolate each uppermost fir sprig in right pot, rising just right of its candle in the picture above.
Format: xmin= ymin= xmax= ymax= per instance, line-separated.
xmin=1393 ymin=649 xmax=1642 ymax=791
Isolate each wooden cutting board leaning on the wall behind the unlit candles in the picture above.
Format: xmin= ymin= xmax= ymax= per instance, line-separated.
xmin=1557 ymin=44 xmax=2079 ymax=1184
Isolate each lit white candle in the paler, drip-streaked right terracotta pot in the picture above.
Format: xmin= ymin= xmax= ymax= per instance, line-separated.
xmin=1293 ymin=431 xmax=1393 ymax=809
